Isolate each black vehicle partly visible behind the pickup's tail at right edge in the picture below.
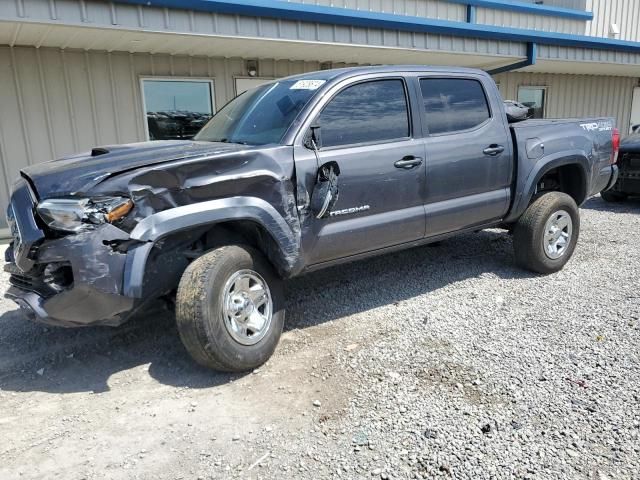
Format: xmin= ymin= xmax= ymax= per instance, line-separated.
xmin=601 ymin=125 xmax=640 ymax=202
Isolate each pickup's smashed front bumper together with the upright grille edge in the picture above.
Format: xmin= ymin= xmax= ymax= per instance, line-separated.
xmin=4 ymin=180 xmax=139 ymax=326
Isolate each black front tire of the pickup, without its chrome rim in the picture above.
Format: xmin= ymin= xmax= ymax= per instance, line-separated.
xmin=176 ymin=245 xmax=285 ymax=372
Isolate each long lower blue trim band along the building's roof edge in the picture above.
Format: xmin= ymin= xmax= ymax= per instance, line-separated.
xmin=113 ymin=0 xmax=640 ymax=54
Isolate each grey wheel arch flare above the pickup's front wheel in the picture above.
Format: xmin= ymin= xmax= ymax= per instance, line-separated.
xmin=124 ymin=196 xmax=300 ymax=297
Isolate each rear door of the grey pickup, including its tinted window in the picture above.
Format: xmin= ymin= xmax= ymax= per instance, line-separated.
xmin=419 ymin=74 xmax=513 ymax=237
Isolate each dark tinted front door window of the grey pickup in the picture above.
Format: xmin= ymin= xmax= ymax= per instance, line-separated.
xmin=318 ymin=79 xmax=410 ymax=147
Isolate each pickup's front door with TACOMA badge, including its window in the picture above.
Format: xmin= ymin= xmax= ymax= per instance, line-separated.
xmin=295 ymin=77 xmax=425 ymax=265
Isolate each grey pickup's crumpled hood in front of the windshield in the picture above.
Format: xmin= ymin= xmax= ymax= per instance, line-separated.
xmin=22 ymin=140 xmax=247 ymax=199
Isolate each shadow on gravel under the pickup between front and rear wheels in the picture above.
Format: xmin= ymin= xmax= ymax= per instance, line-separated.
xmin=285 ymin=230 xmax=535 ymax=329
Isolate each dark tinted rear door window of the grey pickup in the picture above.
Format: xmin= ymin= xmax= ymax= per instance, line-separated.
xmin=420 ymin=78 xmax=491 ymax=135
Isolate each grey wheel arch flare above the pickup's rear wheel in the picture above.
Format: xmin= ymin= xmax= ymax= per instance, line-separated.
xmin=505 ymin=150 xmax=590 ymax=222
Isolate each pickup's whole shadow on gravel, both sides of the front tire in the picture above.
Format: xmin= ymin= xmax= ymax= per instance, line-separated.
xmin=0 ymin=230 xmax=532 ymax=393
